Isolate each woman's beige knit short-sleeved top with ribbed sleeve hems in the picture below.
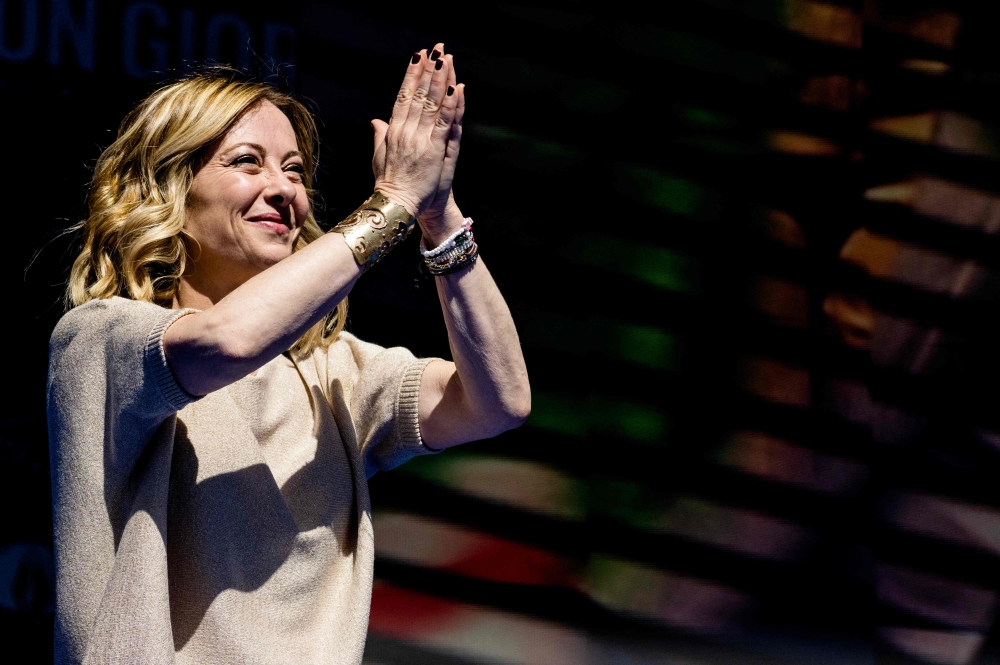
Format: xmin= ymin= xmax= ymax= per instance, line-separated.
xmin=48 ymin=298 xmax=431 ymax=665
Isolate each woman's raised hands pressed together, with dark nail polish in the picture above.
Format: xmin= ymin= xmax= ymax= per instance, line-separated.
xmin=372 ymin=43 xmax=465 ymax=246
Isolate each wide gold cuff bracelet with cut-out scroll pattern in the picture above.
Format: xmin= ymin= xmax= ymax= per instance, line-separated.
xmin=330 ymin=191 xmax=417 ymax=272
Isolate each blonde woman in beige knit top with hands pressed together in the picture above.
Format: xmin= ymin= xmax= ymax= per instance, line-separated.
xmin=48 ymin=44 xmax=530 ymax=663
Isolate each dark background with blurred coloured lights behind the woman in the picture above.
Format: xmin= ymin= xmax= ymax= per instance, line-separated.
xmin=0 ymin=0 xmax=1000 ymax=665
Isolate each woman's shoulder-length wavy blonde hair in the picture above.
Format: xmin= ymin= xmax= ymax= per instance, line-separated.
xmin=65 ymin=68 xmax=347 ymax=353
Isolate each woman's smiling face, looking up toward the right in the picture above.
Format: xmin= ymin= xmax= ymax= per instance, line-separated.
xmin=183 ymin=100 xmax=309 ymax=302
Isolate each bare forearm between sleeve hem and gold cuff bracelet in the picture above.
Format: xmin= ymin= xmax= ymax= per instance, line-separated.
xmin=164 ymin=233 xmax=361 ymax=395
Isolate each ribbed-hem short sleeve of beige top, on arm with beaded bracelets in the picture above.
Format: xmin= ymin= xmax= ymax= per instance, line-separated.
xmin=330 ymin=333 xmax=437 ymax=477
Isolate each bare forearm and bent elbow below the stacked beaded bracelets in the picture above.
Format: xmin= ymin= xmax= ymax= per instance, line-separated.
xmin=420 ymin=260 xmax=531 ymax=448
